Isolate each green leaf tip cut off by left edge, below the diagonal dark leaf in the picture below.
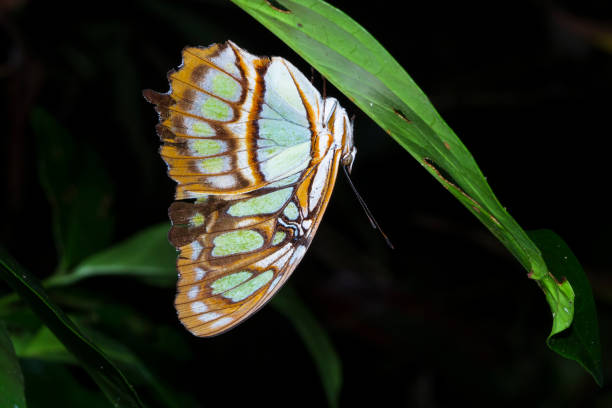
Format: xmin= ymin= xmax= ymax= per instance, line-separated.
xmin=0 ymin=321 xmax=26 ymax=408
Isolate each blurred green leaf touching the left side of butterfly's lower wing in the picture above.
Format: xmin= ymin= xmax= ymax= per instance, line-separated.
xmin=46 ymin=223 xmax=176 ymax=285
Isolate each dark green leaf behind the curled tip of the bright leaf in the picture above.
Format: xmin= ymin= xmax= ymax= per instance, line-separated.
xmin=529 ymin=230 xmax=603 ymax=386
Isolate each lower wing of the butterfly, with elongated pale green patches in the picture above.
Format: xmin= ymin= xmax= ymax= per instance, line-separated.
xmin=170 ymin=142 xmax=340 ymax=336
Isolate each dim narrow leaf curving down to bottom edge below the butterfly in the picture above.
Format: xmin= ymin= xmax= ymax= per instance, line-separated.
xmin=270 ymin=286 xmax=342 ymax=407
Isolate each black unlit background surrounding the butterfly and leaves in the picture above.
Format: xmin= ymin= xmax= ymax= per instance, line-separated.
xmin=0 ymin=0 xmax=612 ymax=407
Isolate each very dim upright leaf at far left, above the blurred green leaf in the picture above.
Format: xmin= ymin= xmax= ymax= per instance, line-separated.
xmin=30 ymin=108 xmax=113 ymax=272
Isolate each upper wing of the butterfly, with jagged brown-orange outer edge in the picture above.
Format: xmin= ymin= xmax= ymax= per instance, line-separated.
xmin=145 ymin=41 xmax=321 ymax=200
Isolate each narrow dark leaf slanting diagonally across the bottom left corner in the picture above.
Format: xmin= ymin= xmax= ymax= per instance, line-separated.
xmin=0 ymin=247 xmax=143 ymax=408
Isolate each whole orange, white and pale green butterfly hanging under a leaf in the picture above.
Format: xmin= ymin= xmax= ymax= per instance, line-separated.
xmin=143 ymin=41 xmax=356 ymax=337
